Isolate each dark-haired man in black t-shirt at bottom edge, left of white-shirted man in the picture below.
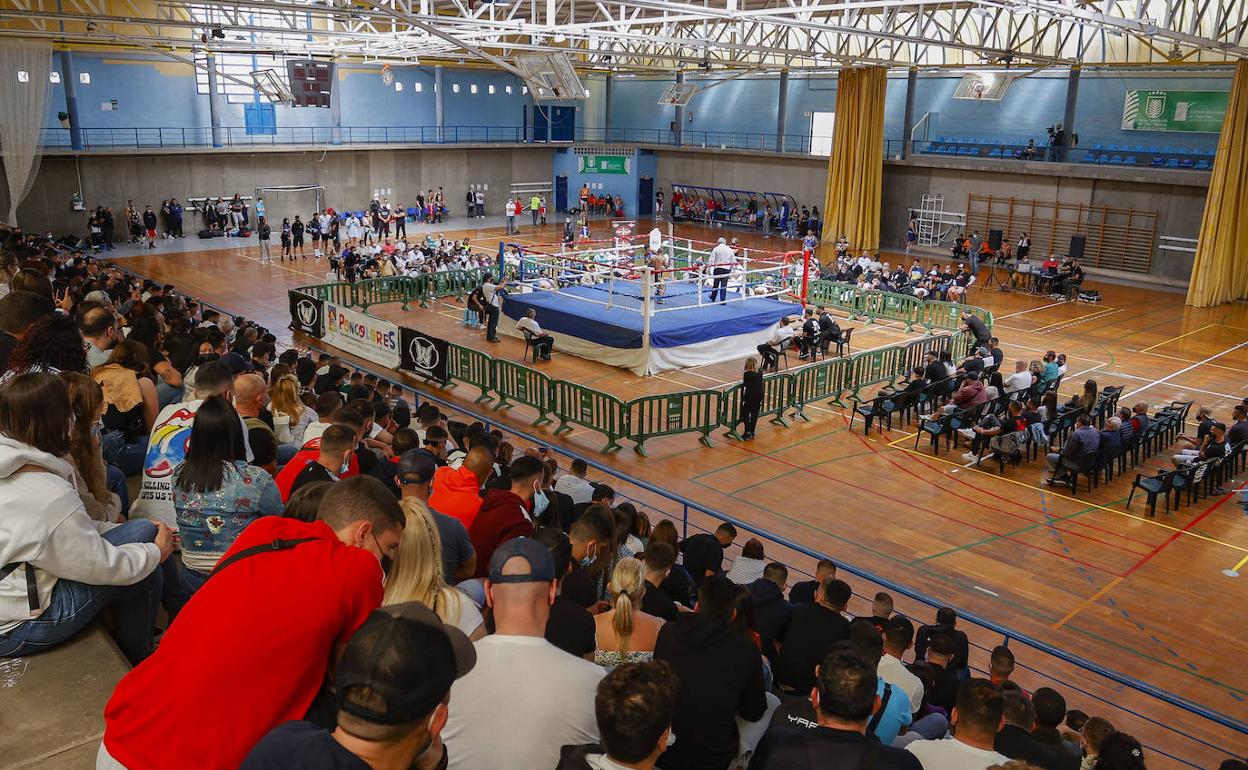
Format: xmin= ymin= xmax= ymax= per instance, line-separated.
xmin=750 ymin=641 xmax=922 ymax=770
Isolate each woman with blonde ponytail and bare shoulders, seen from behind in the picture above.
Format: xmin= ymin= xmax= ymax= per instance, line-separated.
xmin=594 ymin=557 xmax=663 ymax=671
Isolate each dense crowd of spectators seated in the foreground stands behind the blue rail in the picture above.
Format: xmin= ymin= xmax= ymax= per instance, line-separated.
xmin=0 ymin=223 xmax=1238 ymax=770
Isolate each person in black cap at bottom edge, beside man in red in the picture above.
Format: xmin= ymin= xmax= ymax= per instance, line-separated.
xmin=241 ymin=602 xmax=477 ymax=770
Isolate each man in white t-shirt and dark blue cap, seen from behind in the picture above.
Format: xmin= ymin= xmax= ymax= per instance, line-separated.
xmin=443 ymin=538 xmax=604 ymax=770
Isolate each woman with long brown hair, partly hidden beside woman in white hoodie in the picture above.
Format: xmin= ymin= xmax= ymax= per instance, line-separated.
xmin=59 ymin=372 xmax=126 ymax=523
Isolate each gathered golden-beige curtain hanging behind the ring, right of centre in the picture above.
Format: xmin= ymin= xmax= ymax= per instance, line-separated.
xmin=824 ymin=67 xmax=889 ymax=250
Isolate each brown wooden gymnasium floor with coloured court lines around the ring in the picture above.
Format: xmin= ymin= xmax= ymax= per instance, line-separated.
xmin=121 ymin=221 xmax=1248 ymax=768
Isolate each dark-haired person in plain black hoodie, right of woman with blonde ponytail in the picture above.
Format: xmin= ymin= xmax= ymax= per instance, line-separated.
xmin=654 ymin=575 xmax=768 ymax=770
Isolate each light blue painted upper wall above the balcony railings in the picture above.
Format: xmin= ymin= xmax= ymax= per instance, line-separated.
xmin=44 ymin=52 xmax=1231 ymax=150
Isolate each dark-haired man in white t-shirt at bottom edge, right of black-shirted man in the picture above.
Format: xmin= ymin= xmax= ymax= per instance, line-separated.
xmin=906 ymin=679 xmax=1008 ymax=770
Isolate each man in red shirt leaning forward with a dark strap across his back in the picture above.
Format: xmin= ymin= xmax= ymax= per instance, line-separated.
xmin=103 ymin=477 xmax=406 ymax=770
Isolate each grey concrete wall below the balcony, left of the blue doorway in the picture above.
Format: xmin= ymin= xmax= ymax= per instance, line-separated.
xmin=9 ymin=147 xmax=554 ymax=233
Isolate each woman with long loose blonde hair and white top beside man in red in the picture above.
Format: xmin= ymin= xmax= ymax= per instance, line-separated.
xmin=382 ymin=498 xmax=485 ymax=641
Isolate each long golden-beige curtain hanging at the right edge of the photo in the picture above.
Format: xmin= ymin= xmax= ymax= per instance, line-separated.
xmin=1187 ymin=60 xmax=1248 ymax=307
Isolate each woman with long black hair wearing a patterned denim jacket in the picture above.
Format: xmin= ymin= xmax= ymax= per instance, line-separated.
xmin=172 ymin=396 xmax=282 ymax=608
